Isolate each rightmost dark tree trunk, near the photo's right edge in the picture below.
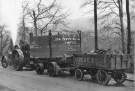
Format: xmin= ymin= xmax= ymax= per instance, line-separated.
xmin=126 ymin=0 xmax=131 ymax=54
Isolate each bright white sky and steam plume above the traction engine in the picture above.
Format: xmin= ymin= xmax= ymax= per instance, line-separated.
xmin=0 ymin=0 xmax=20 ymax=43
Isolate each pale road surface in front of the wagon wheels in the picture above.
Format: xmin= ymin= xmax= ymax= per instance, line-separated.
xmin=0 ymin=68 xmax=135 ymax=91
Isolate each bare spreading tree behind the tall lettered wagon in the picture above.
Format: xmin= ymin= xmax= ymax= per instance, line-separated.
xmin=27 ymin=0 xmax=67 ymax=36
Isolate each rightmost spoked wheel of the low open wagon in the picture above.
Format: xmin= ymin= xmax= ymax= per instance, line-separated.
xmin=113 ymin=72 xmax=127 ymax=84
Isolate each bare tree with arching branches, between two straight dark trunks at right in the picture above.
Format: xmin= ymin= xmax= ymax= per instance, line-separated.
xmin=82 ymin=0 xmax=125 ymax=53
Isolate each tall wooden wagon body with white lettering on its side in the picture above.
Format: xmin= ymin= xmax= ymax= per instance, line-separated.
xmin=30 ymin=31 xmax=81 ymax=58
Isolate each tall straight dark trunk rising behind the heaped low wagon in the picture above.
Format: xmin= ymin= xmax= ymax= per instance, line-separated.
xmin=94 ymin=0 xmax=98 ymax=50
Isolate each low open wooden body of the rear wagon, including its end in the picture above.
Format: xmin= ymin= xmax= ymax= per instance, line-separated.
xmin=73 ymin=53 xmax=130 ymax=70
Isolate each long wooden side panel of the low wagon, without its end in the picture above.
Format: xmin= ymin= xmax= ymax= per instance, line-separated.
xmin=74 ymin=54 xmax=109 ymax=68
